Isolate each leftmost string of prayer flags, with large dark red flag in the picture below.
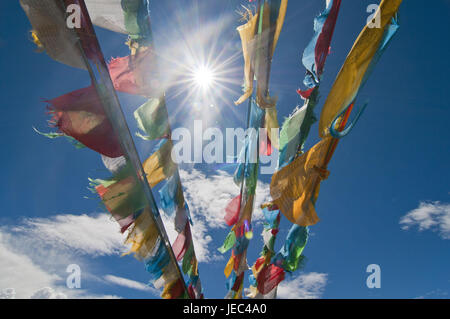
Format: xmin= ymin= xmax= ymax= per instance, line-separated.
xmin=23 ymin=0 xmax=195 ymax=298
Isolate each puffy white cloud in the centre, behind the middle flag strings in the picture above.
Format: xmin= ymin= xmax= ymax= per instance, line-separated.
xmin=180 ymin=169 xmax=270 ymax=228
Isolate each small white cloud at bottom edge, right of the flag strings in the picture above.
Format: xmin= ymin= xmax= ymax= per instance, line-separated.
xmin=278 ymin=272 xmax=328 ymax=299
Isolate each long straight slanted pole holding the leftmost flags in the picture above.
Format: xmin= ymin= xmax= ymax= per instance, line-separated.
xmin=71 ymin=0 xmax=188 ymax=293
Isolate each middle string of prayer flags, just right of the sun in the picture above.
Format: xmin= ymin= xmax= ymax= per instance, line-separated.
xmin=221 ymin=0 xmax=287 ymax=299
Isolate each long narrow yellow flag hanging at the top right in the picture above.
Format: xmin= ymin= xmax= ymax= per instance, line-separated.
xmin=319 ymin=0 xmax=402 ymax=138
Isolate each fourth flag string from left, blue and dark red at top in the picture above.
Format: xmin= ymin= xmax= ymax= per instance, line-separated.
xmin=248 ymin=0 xmax=341 ymax=299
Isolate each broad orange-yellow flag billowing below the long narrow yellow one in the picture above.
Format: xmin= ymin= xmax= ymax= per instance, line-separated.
xmin=270 ymin=137 xmax=333 ymax=226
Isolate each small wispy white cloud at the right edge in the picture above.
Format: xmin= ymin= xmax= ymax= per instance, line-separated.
xmin=400 ymin=202 xmax=450 ymax=239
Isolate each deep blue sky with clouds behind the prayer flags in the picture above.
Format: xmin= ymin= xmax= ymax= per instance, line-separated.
xmin=0 ymin=0 xmax=450 ymax=298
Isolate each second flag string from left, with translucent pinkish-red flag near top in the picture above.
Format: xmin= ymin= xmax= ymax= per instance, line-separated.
xmin=110 ymin=0 xmax=203 ymax=298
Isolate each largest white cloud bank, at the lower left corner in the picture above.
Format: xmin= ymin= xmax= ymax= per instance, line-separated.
xmin=0 ymin=214 xmax=125 ymax=299
